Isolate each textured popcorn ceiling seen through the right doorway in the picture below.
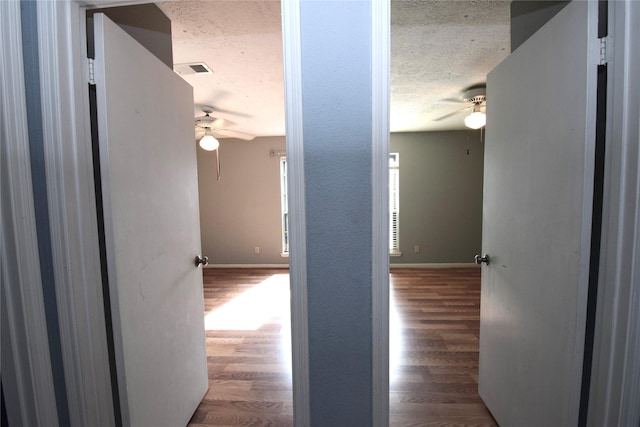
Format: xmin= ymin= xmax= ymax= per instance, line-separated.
xmin=391 ymin=1 xmax=510 ymax=132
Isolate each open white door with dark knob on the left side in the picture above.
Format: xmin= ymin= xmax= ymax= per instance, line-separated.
xmin=94 ymin=14 xmax=208 ymax=427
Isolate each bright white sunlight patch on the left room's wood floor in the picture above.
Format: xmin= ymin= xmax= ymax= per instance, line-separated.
xmin=204 ymin=274 xmax=290 ymax=331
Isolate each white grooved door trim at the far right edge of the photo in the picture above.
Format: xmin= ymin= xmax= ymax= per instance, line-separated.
xmin=587 ymin=0 xmax=640 ymax=426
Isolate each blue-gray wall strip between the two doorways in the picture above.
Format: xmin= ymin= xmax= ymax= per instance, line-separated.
xmin=300 ymin=1 xmax=373 ymax=427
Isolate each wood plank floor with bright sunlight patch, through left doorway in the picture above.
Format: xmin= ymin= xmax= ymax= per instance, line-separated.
xmin=189 ymin=269 xmax=293 ymax=427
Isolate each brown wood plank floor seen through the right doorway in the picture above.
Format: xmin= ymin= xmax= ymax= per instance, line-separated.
xmin=389 ymin=268 xmax=496 ymax=426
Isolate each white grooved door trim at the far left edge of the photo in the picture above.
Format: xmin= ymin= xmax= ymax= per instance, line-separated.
xmin=0 ymin=1 xmax=58 ymax=425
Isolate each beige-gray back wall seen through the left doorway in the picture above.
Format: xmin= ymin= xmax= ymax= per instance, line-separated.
xmin=197 ymin=137 xmax=289 ymax=265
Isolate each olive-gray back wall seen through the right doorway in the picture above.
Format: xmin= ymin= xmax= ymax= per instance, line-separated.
xmin=390 ymin=131 xmax=484 ymax=264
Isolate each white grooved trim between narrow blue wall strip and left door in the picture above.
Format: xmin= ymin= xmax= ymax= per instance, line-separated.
xmin=38 ymin=2 xmax=114 ymax=426
